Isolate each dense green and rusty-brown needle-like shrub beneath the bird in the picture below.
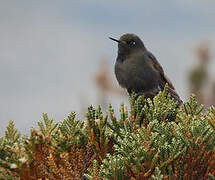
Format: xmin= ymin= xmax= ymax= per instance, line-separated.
xmin=0 ymin=86 xmax=215 ymax=180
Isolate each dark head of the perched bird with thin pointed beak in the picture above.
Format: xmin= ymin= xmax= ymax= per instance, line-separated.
xmin=109 ymin=34 xmax=145 ymax=56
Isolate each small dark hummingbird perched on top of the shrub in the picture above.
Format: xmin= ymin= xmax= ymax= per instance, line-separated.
xmin=109 ymin=33 xmax=183 ymax=106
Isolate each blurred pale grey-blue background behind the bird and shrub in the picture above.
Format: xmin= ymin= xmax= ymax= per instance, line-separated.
xmin=0 ymin=0 xmax=215 ymax=135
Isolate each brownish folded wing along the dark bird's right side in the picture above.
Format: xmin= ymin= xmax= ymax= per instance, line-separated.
xmin=146 ymin=51 xmax=175 ymax=90
